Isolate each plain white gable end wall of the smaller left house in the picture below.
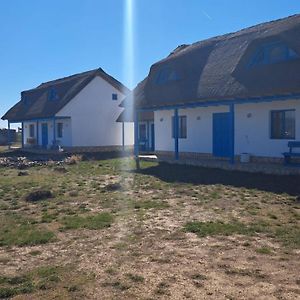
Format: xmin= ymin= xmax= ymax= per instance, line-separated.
xmin=56 ymin=76 xmax=134 ymax=147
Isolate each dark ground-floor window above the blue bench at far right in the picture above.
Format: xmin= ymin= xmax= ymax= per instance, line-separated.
xmin=271 ymin=110 xmax=295 ymax=139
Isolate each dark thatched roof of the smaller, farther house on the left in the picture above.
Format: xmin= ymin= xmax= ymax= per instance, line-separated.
xmin=2 ymin=68 xmax=129 ymax=121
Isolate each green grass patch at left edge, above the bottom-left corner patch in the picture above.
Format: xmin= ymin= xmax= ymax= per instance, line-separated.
xmin=0 ymin=214 xmax=55 ymax=246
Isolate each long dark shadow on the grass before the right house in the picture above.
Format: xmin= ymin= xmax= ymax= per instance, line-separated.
xmin=138 ymin=163 xmax=300 ymax=198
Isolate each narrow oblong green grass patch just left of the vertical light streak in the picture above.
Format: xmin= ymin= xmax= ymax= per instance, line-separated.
xmin=62 ymin=212 xmax=114 ymax=230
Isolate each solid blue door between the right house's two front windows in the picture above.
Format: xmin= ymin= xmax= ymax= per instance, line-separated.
xmin=213 ymin=113 xmax=230 ymax=157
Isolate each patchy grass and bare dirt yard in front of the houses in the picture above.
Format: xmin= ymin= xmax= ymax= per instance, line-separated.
xmin=0 ymin=157 xmax=300 ymax=299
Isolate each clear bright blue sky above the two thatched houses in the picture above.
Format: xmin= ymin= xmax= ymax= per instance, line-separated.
xmin=0 ymin=0 xmax=300 ymax=128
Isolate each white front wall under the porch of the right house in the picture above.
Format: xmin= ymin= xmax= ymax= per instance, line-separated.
xmin=154 ymin=100 xmax=300 ymax=157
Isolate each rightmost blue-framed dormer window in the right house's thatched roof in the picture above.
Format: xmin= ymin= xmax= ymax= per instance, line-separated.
xmin=249 ymin=42 xmax=299 ymax=67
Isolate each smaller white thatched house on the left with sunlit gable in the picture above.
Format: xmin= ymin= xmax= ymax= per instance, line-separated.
xmin=2 ymin=69 xmax=133 ymax=149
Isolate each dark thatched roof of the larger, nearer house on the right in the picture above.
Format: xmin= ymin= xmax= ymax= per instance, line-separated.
xmin=125 ymin=15 xmax=300 ymax=108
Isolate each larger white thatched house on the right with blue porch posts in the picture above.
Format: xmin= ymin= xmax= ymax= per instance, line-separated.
xmin=125 ymin=15 xmax=300 ymax=162
